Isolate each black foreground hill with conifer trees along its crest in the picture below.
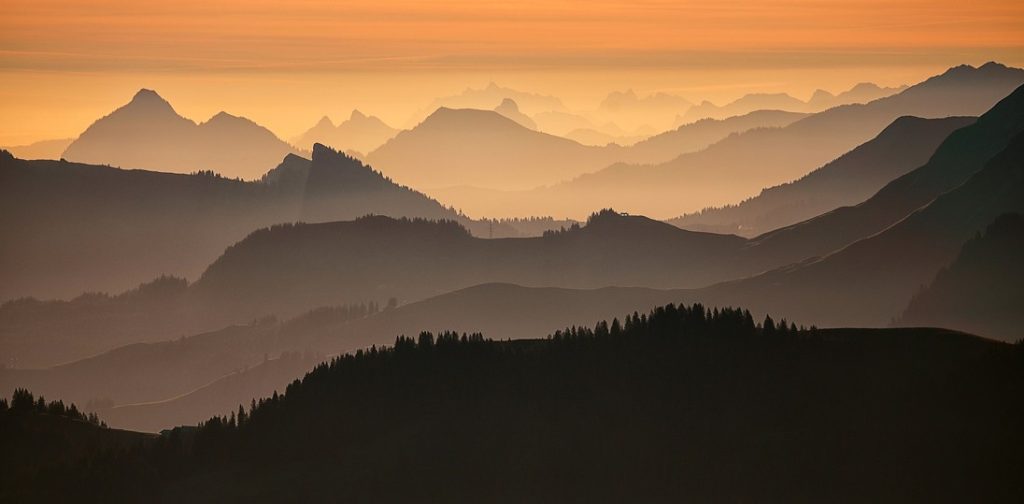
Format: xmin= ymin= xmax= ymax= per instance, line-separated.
xmin=4 ymin=305 xmax=1024 ymax=502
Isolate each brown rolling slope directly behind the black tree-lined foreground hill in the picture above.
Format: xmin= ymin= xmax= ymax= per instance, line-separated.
xmin=0 ymin=284 xmax=684 ymax=431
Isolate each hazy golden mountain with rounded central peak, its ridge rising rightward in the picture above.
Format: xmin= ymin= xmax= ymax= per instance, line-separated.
xmin=367 ymin=109 xmax=803 ymax=193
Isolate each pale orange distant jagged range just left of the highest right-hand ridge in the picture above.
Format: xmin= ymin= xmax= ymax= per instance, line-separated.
xmin=680 ymin=82 xmax=906 ymax=123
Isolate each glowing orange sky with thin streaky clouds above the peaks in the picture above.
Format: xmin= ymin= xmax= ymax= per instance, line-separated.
xmin=0 ymin=0 xmax=1024 ymax=144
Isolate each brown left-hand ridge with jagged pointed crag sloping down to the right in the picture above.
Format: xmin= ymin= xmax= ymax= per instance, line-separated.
xmin=0 ymin=145 xmax=562 ymax=300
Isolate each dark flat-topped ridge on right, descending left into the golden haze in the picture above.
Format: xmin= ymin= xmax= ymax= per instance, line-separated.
xmin=669 ymin=117 xmax=975 ymax=237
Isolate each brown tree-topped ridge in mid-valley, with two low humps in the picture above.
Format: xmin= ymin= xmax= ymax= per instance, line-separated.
xmin=193 ymin=211 xmax=745 ymax=317
